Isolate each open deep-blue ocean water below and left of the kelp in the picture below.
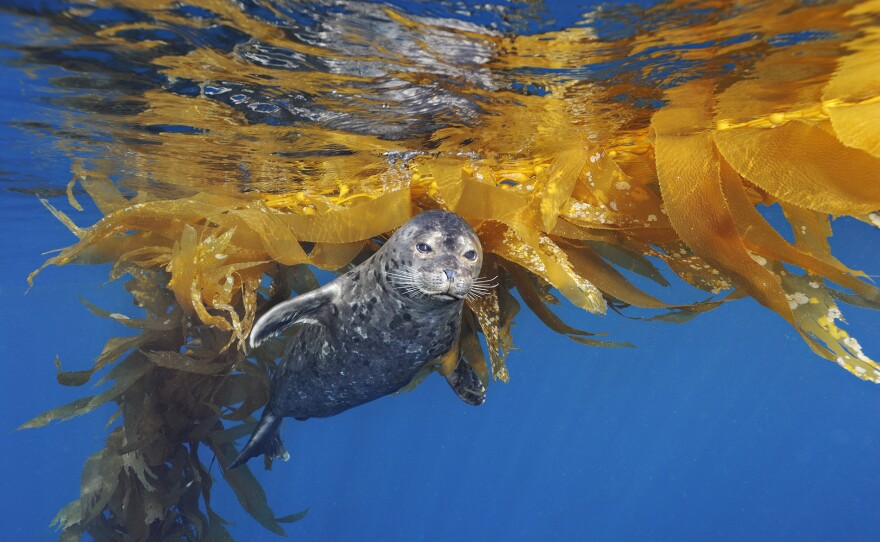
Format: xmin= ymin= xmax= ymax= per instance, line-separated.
xmin=0 ymin=1 xmax=880 ymax=541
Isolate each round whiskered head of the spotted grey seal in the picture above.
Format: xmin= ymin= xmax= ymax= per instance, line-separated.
xmin=382 ymin=210 xmax=485 ymax=302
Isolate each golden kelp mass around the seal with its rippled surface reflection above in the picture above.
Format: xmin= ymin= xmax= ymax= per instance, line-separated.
xmin=8 ymin=0 xmax=880 ymax=540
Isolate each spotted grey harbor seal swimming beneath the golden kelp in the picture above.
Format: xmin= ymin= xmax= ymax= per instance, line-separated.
xmin=229 ymin=210 xmax=490 ymax=468
